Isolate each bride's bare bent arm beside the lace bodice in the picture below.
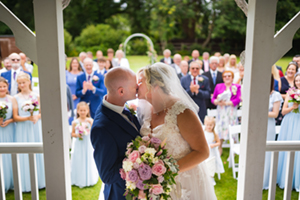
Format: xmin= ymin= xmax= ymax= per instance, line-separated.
xmin=177 ymin=110 xmax=209 ymax=172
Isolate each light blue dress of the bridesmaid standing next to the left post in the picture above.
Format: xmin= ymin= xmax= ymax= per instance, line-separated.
xmin=15 ymin=94 xmax=45 ymax=192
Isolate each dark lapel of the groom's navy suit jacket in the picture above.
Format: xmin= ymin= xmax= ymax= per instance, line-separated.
xmin=101 ymin=104 xmax=139 ymax=138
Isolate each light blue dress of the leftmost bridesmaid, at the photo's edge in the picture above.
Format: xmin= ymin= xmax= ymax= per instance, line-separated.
xmin=0 ymin=96 xmax=15 ymax=192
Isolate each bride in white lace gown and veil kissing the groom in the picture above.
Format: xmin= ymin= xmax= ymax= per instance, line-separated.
xmin=138 ymin=63 xmax=217 ymax=200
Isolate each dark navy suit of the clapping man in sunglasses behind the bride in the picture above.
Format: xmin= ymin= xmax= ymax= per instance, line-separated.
xmin=181 ymin=74 xmax=210 ymax=122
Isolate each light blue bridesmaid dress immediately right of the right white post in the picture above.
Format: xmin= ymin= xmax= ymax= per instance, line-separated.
xmin=263 ymin=91 xmax=283 ymax=190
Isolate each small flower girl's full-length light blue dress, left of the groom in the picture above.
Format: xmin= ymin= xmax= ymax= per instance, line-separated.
xmin=71 ymin=119 xmax=99 ymax=188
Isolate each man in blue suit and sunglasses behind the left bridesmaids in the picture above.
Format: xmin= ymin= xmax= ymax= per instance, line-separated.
xmin=1 ymin=53 xmax=32 ymax=96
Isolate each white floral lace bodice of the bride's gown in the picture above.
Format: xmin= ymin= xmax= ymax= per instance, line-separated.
xmin=140 ymin=101 xmax=192 ymax=160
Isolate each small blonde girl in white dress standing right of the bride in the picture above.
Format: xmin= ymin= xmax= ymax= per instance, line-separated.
xmin=204 ymin=116 xmax=224 ymax=184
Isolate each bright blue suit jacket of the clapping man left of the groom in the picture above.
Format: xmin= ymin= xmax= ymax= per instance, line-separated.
xmin=76 ymin=72 xmax=106 ymax=118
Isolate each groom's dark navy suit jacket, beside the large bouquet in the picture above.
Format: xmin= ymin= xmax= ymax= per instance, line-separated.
xmin=91 ymin=104 xmax=140 ymax=200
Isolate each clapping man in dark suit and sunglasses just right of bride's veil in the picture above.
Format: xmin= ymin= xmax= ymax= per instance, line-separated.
xmin=181 ymin=61 xmax=210 ymax=122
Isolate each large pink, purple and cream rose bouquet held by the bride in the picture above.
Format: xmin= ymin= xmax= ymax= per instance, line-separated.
xmin=120 ymin=136 xmax=179 ymax=200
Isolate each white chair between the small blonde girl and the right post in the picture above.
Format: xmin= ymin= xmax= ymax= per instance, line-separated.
xmin=229 ymin=125 xmax=241 ymax=179
